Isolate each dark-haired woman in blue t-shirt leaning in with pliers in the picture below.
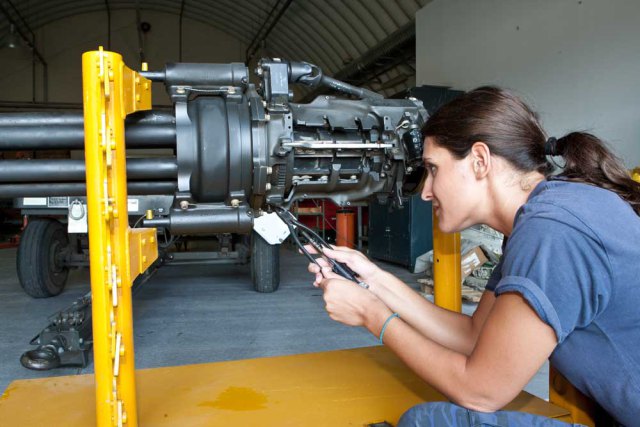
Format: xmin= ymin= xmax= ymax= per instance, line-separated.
xmin=309 ymin=87 xmax=640 ymax=426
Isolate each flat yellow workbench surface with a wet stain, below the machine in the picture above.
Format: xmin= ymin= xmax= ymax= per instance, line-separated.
xmin=0 ymin=347 xmax=571 ymax=427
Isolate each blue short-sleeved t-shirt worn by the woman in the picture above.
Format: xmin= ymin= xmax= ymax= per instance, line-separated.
xmin=487 ymin=180 xmax=640 ymax=426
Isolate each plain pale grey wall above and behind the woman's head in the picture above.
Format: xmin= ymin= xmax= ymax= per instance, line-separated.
xmin=416 ymin=0 xmax=640 ymax=167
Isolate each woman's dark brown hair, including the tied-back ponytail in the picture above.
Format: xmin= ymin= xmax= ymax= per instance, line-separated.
xmin=422 ymin=86 xmax=640 ymax=215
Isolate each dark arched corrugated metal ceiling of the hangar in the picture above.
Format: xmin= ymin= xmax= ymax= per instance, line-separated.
xmin=0 ymin=0 xmax=430 ymax=96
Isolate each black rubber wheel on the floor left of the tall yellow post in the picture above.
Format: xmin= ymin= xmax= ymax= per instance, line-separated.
xmin=16 ymin=218 xmax=69 ymax=298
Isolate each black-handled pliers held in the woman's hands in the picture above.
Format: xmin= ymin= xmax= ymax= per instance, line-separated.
xmin=275 ymin=207 xmax=369 ymax=289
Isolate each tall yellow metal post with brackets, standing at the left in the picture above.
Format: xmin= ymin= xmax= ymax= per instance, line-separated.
xmin=82 ymin=47 xmax=157 ymax=427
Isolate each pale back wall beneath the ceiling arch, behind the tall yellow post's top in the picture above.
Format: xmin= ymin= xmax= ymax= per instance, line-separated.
xmin=0 ymin=10 xmax=246 ymax=105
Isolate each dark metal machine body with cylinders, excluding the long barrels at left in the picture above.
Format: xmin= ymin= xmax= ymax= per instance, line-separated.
xmin=142 ymin=60 xmax=427 ymax=234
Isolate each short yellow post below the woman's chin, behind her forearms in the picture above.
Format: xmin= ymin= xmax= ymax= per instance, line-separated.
xmin=433 ymin=213 xmax=462 ymax=313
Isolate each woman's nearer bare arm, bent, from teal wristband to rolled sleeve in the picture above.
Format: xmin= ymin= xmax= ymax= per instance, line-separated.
xmin=365 ymin=293 xmax=557 ymax=412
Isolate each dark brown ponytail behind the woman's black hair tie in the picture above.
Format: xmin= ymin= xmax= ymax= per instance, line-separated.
xmin=555 ymin=132 xmax=640 ymax=215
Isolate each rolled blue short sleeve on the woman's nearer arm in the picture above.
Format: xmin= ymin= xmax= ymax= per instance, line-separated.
xmin=494 ymin=206 xmax=611 ymax=343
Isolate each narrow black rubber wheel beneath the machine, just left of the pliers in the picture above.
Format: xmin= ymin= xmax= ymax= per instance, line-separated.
xmin=251 ymin=231 xmax=280 ymax=293
